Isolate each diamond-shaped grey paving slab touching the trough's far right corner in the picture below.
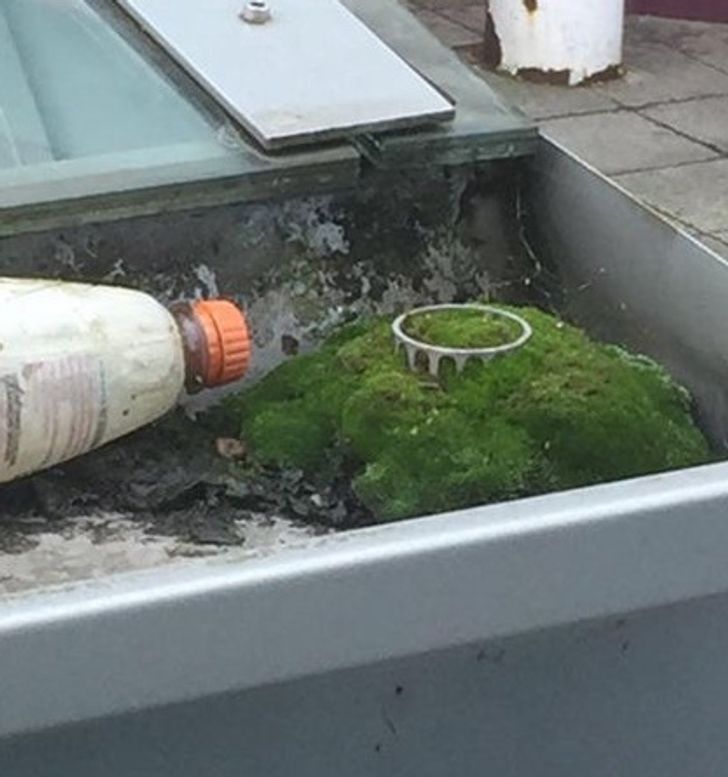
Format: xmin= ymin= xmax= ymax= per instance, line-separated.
xmin=541 ymin=111 xmax=716 ymax=174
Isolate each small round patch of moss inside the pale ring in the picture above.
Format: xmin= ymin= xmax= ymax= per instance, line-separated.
xmin=404 ymin=309 xmax=522 ymax=348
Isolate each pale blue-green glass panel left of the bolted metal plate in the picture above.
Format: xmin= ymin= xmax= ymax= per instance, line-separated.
xmin=0 ymin=0 xmax=242 ymax=206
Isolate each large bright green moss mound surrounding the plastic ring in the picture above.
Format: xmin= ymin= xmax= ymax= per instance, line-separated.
xmin=226 ymin=309 xmax=710 ymax=520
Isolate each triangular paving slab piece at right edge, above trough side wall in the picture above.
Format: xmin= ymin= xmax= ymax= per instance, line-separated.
xmin=615 ymin=159 xmax=728 ymax=235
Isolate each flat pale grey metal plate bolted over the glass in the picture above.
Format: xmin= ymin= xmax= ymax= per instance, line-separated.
xmin=116 ymin=0 xmax=455 ymax=150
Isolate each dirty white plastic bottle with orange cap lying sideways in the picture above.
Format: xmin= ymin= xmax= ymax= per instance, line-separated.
xmin=0 ymin=278 xmax=250 ymax=483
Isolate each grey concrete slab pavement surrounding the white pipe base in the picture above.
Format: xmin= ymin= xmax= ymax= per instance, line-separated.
xmin=409 ymin=0 xmax=728 ymax=257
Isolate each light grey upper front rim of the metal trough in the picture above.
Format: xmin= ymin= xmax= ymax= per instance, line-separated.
xmin=0 ymin=464 xmax=728 ymax=737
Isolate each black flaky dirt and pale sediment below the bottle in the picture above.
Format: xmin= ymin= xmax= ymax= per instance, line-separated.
xmin=0 ymin=414 xmax=368 ymax=566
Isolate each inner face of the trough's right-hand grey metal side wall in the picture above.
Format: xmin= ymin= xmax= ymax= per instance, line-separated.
xmin=525 ymin=136 xmax=728 ymax=449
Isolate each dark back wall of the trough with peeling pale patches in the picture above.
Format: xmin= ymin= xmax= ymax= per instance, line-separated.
xmin=0 ymin=165 xmax=528 ymax=413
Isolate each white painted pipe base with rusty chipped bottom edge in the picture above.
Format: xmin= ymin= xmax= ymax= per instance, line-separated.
xmin=490 ymin=0 xmax=624 ymax=86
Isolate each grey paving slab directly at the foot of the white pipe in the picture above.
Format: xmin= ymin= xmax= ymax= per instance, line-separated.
xmin=479 ymin=70 xmax=619 ymax=119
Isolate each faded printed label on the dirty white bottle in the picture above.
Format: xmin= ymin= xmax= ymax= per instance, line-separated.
xmin=0 ymin=354 xmax=108 ymax=469
